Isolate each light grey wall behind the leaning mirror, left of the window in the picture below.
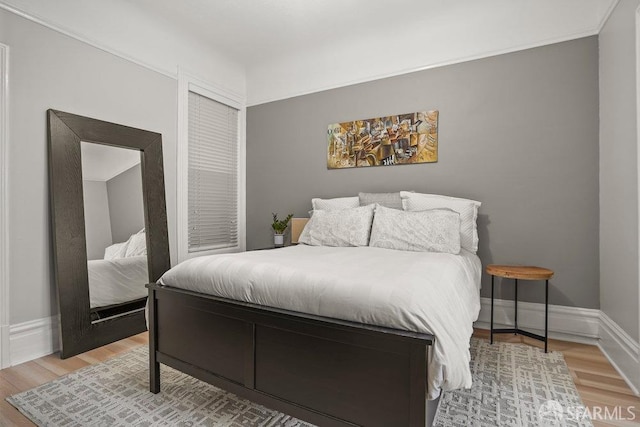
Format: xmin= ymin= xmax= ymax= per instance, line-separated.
xmin=0 ymin=10 xmax=177 ymax=325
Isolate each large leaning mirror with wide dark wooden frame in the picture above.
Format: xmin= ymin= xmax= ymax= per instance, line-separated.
xmin=47 ymin=110 xmax=170 ymax=358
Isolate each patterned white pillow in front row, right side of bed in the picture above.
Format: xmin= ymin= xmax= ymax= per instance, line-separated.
xmin=369 ymin=205 xmax=460 ymax=254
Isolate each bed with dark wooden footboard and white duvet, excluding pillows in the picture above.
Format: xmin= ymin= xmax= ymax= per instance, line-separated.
xmin=148 ymin=195 xmax=481 ymax=427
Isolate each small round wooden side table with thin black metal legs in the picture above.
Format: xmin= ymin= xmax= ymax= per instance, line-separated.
xmin=486 ymin=264 xmax=553 ymax=353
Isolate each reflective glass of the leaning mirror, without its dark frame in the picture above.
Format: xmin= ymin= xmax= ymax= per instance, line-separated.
xmin=81 ymin=141 xmax=149 ymax=323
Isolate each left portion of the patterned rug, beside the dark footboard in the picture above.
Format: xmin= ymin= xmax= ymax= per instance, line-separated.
xmin=6 ymin=347 xmax=312 ymax=427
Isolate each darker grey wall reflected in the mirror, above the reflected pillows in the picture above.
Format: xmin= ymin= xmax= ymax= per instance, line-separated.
xmin=107 ymin=164 xmax=144 ymax=243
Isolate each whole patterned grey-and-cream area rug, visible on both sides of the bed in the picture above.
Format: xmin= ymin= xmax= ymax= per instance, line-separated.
xmin=7 ymin=339 xmax=591 ymax=427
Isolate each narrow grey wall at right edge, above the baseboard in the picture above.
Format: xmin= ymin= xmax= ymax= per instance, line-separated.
xmin=600 ymin=0 xmax=640 ymax=340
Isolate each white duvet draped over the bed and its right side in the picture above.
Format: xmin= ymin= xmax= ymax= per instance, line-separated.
xmin=159 ymin=245 xmax=482 ymax=399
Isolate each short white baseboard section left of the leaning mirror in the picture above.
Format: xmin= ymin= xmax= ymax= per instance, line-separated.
xmin=9 ymin=316 xmax=60 ymax=366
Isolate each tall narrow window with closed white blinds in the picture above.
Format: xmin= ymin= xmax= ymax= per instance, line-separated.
xmin=178 ymin=75 xmax=244 ymax=261
